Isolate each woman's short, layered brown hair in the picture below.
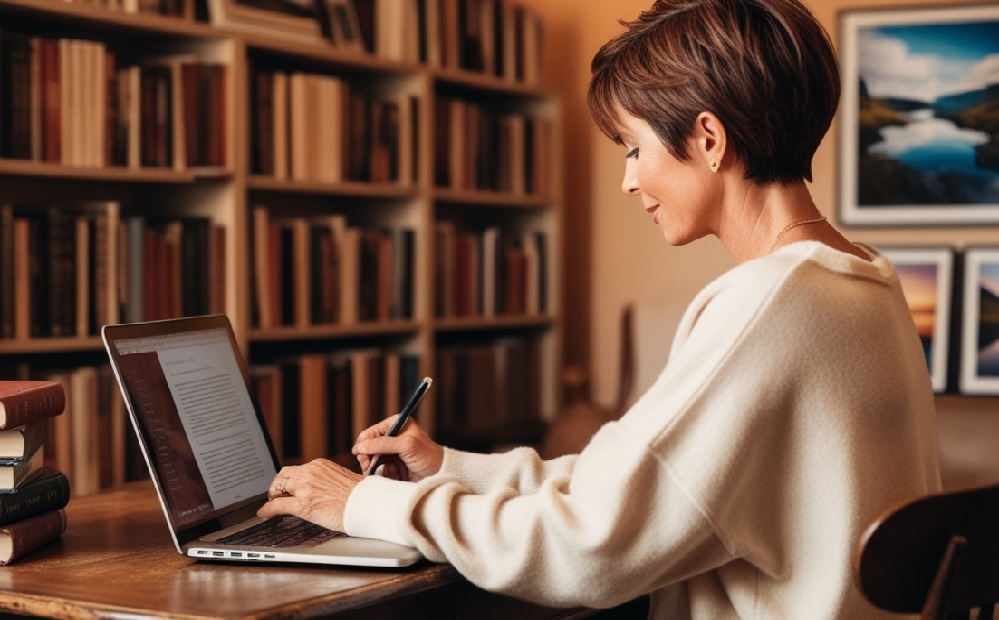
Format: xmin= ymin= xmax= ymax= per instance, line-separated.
xmin=588 ymin=0 xmax=840 ymax=184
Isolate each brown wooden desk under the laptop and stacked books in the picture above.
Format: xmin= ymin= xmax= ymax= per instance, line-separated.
xmin=0 ymin=483 xmax=589 ymax=620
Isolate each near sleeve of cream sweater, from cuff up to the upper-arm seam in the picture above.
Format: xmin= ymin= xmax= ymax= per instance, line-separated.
xmin=345 ymin=423 xmax=730 ymax=607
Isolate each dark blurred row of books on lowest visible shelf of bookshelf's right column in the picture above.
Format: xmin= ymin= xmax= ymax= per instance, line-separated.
xmin=435 ymin=338 xmax=542 ymax=435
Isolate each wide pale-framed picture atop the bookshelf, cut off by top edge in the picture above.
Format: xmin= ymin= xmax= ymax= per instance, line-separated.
xmin=208 ymin=0 xmax=323 ymax=41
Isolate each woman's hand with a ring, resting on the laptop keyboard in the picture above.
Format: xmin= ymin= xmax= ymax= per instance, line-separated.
xmin=257 ymin=459 xmax=363 ymax=532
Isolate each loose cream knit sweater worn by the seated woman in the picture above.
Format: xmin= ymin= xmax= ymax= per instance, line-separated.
xmin=345 ymin=242 xmax=940 ymax=620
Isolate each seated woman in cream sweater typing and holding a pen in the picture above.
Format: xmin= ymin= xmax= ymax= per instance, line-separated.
xmin=260 ymin=0 xmax=940 ymax=619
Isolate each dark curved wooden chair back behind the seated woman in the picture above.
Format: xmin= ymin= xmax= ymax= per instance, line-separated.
xmin=854 ymin=485 xmax=999 ymax=620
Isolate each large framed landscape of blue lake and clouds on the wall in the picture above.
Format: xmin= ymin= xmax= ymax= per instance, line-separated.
xmin=838 ymin=3 xmax=999 ymax=226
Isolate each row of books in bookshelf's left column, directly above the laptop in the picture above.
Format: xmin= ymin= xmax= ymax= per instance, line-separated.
xmin=0 ymin=201 xmax=226 ymax=339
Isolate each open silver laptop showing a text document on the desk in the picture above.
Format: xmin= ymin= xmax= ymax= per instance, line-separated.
xmin=101 ymin=315 xmax=423 ymax=568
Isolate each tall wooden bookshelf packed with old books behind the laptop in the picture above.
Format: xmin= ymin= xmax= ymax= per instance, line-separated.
xmin=0 ymin=0 xmax=561 ymax=494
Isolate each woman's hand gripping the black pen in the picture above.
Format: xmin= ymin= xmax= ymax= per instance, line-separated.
xmin=351 ymin=416 xmax=444 ymax=482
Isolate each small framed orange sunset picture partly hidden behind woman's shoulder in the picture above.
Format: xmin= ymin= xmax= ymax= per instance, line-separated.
xmin=879 ymin=247 xmax=954 ymax=392
